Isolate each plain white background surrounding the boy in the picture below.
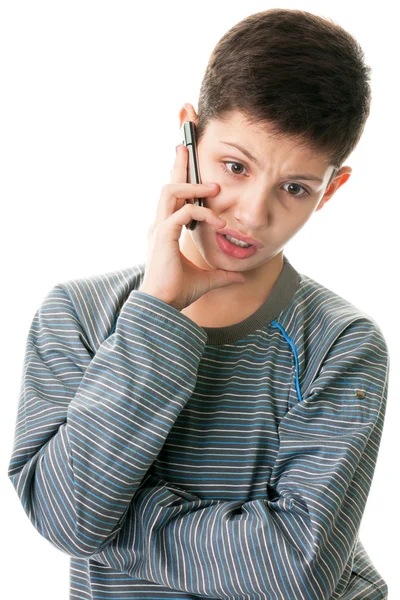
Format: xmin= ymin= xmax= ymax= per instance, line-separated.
xmin=0 ymin=0 xmax=400 ymax=600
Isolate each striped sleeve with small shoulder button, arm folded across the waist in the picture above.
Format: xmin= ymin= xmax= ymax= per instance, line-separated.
xmin=126 ymin=318 xmax=389 ymax=600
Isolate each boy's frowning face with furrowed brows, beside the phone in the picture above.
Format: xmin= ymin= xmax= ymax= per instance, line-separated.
xmin=180 ymin=104 xmax=351 ymax=291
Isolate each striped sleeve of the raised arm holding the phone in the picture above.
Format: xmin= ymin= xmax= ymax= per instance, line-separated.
xmin=8 ymin=284 xmax=207 ymax=557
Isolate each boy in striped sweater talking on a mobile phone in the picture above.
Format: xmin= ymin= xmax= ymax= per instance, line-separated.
xmin=9 ymin=9 xmax=389 ymax=600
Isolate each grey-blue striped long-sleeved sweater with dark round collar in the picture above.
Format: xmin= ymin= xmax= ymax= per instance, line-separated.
xmin=8 ymin=256 xmax=389 ymax=600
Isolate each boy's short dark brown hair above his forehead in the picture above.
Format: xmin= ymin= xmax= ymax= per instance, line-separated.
xmin=196 ymin=8 xmax=371 ymax=180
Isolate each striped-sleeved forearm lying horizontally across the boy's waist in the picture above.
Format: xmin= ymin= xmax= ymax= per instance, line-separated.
xmin=133 ymin=478 xmax=318 ymax=600
